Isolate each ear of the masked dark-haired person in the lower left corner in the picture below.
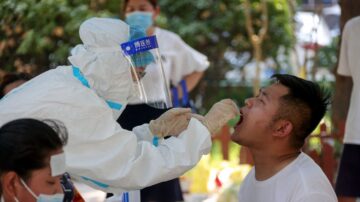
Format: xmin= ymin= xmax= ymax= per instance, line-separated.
xmin=0 ymin=171 xmax=19 ymax=201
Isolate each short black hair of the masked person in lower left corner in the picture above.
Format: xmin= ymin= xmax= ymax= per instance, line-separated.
xmin=0 ymin=118 xmax=68 ymax=184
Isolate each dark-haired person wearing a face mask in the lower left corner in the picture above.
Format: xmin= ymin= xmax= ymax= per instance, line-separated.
xmin=0 ymin=119 xmax=70 ymax=202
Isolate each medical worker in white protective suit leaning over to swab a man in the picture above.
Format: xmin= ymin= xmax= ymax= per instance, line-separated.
xmin=0 ymin=18 xmax=239 ymax=196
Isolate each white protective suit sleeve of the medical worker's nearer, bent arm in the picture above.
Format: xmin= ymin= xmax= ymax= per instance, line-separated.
xmin=66 ymin=118 xmax=211 ymax=193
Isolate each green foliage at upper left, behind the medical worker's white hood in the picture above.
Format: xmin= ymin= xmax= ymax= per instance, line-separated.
xmin=0 ymin=0 xmax=121 ymax=74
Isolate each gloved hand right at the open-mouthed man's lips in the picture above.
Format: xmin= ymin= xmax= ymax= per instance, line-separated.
xmin=192 ymin=99 xmax=240 ymax=134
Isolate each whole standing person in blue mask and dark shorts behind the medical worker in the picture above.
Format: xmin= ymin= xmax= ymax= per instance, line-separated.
xmin=118 ymin=0 xmax=209 ymax=201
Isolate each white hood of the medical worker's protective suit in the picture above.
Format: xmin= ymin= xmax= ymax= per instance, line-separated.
xmin=68 ymin=18 xmax=132 ymax=118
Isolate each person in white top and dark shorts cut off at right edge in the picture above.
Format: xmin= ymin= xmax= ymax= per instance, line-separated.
xmin=335 ymin=17 xmax=360 ymax=202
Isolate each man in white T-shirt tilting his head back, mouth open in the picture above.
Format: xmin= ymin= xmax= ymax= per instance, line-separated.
xmin=231 ymin=74 xmax=337 ymax=202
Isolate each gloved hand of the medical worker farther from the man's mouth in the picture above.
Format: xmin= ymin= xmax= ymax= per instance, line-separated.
xmin=149 ymin=108 xmax=191 ymax=137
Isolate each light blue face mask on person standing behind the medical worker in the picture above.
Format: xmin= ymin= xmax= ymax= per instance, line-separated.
xmin=125 ymin=11 xmax=153 ymax=30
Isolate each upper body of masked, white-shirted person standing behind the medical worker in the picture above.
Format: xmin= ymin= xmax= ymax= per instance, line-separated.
xmin=123 ymin=0 xmax=209 ymax=107
